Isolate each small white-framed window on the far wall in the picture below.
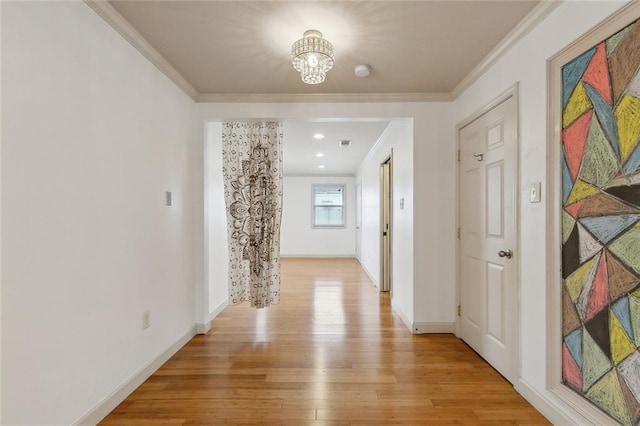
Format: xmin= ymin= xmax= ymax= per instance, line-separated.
xmin=311 ymin=185 xmax=345 ymax=228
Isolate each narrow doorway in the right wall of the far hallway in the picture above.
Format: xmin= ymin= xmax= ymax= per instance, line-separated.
xmin=380 ymin=156 xmax=393 ymax=292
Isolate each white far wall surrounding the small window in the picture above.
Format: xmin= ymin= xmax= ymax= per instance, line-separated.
xmin=280 ymin=176 xmax=356 ymax=257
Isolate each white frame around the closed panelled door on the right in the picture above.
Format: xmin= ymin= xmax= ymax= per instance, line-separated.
xmin=454 ymin=82 xmax=522 ymax=390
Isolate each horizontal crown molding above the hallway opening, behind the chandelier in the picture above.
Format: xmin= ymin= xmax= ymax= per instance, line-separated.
xmin=197 ymin=93 xmax=453 ymax=103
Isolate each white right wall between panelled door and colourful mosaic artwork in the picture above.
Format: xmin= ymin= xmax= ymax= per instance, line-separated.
xmin=454 ymin=1 xmax=623 ymax=423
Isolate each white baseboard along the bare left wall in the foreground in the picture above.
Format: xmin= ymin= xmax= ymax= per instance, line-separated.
xmin=73 ymin=326 xmax=196 ymax=426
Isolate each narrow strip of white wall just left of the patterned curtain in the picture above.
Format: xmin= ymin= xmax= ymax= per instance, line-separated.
xmin=205 ymin=122 xmax=229 ymax=326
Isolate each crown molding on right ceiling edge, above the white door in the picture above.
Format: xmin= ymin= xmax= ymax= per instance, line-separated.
xmin=451 ymin=0 xmax=565 ymax=100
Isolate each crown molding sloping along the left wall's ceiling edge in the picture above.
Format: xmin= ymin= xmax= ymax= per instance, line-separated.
xmin=84 ymin=0 xmax=198 ymax=101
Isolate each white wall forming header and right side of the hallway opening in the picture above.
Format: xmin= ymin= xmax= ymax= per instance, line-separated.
xmin=197 ymin=102 xmax=455 ymax=331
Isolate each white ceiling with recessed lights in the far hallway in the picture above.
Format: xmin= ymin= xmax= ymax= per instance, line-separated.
xmin=283 ymin=120 xmax=389 ymax=176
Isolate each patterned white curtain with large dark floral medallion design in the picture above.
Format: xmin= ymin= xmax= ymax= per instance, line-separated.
xmin=222 ymin=122 xmax=282 ymax=308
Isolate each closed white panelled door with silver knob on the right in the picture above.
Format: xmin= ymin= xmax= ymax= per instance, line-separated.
xmin=458 ymin=97 xmax=516 ymax=383
